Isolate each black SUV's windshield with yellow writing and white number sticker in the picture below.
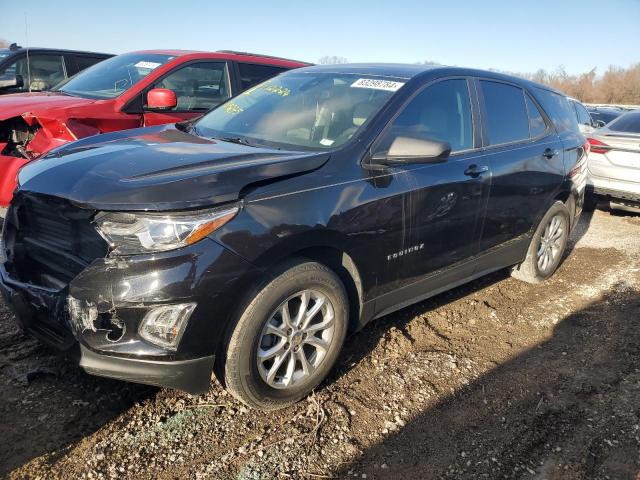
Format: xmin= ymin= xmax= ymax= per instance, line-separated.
xmin=195 ymin=72 xmax=404 ymax=149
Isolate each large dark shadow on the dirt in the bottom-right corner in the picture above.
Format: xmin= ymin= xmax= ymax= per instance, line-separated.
xmin=338 ymin=285 xmax=640 ymax=480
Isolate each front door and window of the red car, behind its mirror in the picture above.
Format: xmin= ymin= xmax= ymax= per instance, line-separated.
xmin=143 ymin=61 xmax=232 ymax=126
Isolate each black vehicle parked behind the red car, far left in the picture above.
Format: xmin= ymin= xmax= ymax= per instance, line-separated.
xmin=0 ymin=43 xmax=113 ymax=95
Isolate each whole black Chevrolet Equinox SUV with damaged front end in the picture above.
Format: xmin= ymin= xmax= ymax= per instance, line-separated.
xmin=0 ymin=64 xmax=586 ymax=409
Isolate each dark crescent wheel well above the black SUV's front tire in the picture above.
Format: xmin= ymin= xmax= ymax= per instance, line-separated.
xmin=293 ymin=247 xmax=362 ymax=329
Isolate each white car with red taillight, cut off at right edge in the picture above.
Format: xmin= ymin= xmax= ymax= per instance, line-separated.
xmin=586 ymin=110 xmax=640 ymax=213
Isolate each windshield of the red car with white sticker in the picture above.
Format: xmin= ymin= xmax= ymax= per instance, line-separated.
xmin=53 ymin=53 xmax=175 ymax=98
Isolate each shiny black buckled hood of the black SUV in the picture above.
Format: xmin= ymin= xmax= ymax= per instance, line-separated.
xmin=18 ymin=125 xmax=329 ymax=211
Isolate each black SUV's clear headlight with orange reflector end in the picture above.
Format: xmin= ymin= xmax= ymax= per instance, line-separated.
xmin=94 ymin=205 xmax=240 ymax=255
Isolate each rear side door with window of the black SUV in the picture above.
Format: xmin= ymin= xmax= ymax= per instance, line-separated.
xmin=477 ymin=79 xmax=564 ymax=258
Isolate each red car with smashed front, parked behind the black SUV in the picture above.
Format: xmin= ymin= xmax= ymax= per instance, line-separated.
xmin=0 ymin=50 xmax=309 ymax=207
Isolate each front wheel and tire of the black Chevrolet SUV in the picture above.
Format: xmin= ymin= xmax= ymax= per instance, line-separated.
xmin=224 ymin=261 xmax=349 ymax=410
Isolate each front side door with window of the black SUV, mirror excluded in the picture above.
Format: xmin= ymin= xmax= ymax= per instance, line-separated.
xmin=374 ymin=78 xmax=491 ymax=310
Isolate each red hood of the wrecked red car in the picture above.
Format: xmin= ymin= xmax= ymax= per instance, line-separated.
xmin=0 ymin=92 xmax=95 ymax=120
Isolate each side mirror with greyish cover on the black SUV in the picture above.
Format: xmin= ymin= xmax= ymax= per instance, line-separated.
xmin=372 ymin=137 xmax=451 ymax=165
